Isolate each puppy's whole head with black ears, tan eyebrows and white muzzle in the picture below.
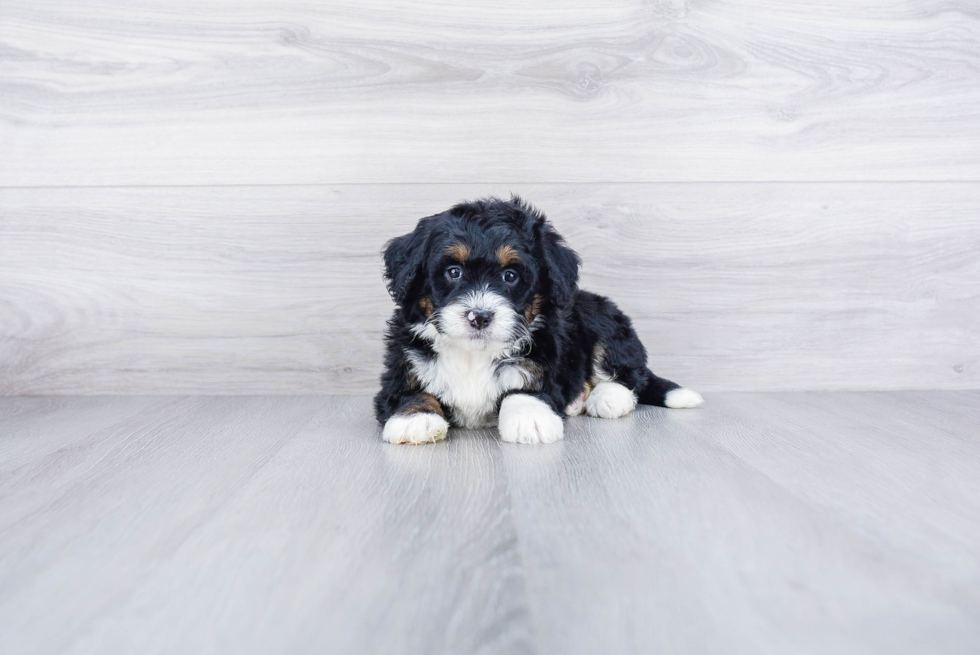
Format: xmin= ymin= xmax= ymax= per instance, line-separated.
xmin=384 ymin=197 xmax=579 ymax=350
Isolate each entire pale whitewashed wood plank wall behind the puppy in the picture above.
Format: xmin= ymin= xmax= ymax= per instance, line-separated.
xmin=0 ymin=0 xmax=980 ymax=394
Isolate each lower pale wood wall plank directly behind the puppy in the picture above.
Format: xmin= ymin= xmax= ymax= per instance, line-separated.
xmin=0 ymin=183 xmax=980 ymax=394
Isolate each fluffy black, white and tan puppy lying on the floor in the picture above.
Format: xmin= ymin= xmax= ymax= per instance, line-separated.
xmin=374 ymin=197 xmax=702 ymax=444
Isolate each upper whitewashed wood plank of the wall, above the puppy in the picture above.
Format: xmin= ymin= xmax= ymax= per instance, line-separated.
xmin=0 ymin=0 xmax=980 ymax=186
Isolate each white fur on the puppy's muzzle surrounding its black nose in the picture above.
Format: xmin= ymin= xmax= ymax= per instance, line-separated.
xmin=437 ymin=289 xmax=520 ymax=350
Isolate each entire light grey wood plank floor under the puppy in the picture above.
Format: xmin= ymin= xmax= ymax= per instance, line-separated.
xmin=0 ymin=391 xmax=980 ymax=655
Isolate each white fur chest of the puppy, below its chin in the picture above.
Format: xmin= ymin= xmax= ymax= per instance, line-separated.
xmin=408 ymin=348 xmax=541 ymax=428
